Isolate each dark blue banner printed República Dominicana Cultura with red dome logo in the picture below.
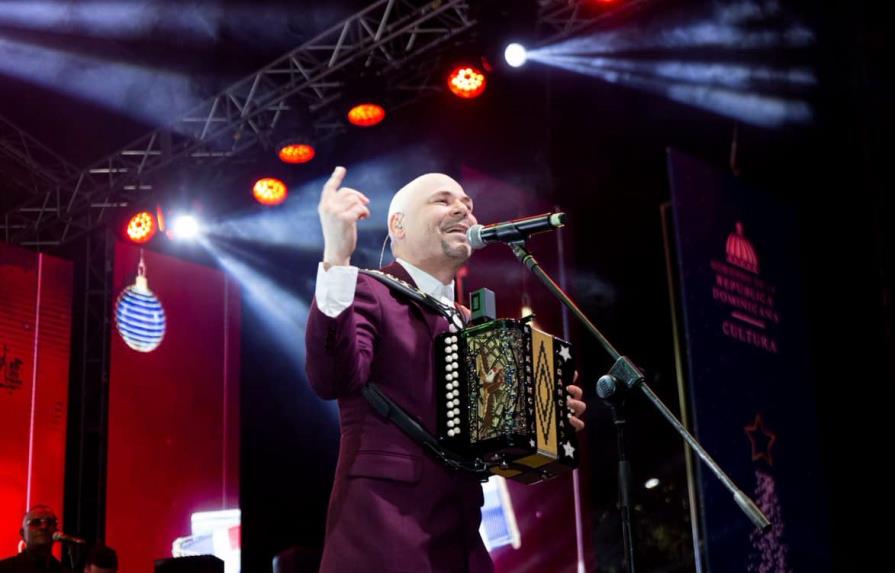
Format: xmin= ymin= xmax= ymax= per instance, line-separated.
xmin=668 ymin=152 xmax=831 ymax=573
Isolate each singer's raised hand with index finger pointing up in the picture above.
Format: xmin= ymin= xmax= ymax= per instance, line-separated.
xmin=317 ymin=167 xmax=370 ymax=265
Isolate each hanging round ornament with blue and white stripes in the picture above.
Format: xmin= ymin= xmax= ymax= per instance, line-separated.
xmin=115 ymin=252 xmax=165 ymax=352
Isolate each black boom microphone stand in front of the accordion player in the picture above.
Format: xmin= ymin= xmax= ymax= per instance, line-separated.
xmin=508 ymin=240 xmax=771 ymax=573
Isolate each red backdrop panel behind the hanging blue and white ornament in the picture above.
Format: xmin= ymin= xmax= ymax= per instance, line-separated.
xmin=106 ymin=243 xmax=240 ymax=573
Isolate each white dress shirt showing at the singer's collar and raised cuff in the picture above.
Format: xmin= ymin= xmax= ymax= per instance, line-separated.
xmin=314 ymin=259 xmax=454 ymax=318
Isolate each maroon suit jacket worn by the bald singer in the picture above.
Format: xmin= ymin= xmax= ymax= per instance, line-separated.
xmin=306 ymin=263 xmax=493 ymax=573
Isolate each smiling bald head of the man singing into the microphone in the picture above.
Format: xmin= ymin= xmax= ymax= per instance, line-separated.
xmin=389 ymin=173 xmax=476 ymax=283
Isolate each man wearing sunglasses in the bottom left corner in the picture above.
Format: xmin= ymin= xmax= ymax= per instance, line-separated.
xmin=0 ymin=505 xmax=70 ymax=573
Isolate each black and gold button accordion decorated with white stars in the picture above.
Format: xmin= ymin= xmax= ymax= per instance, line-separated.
xmin=435 ymin=319 xmax=578 ymax=483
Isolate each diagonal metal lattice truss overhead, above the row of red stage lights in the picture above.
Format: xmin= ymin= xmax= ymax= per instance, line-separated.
xmin=0 ymin=0 xmax=646 ymax=246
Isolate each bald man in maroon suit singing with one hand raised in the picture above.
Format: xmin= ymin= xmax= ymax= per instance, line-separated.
xmin=306 ymin=167 xmax=586 ymax=573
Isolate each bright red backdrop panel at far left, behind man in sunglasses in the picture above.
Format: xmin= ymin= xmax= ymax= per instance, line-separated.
xmin=0 ymin=244 xmax=72 ymax=556
